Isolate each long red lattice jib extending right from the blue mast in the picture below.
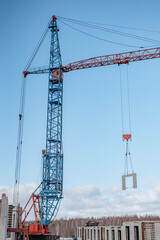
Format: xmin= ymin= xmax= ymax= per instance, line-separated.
xmin=62 ymin=47 xmax=160 ymax=72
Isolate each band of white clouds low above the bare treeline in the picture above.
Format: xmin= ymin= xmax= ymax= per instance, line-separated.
xmin=0 ymin=179 xmax=160 ymax=218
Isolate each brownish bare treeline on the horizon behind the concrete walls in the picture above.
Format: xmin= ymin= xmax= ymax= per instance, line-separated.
xmin=50 ymin=215 xmax=160 ymax=238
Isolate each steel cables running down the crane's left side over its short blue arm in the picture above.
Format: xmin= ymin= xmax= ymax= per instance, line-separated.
xmin=13 ymin=26 xmax=48 ymax=206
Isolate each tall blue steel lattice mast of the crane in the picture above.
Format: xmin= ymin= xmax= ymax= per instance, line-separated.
xmin=40 ymin=15 xmax=63 ymax=225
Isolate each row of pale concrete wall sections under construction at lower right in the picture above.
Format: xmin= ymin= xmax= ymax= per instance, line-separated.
xmin=77 ymin=221 xmax=160 ymax=240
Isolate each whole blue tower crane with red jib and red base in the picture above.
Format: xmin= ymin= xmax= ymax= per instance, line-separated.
xmin=12 ymin=15 xmax=160 ymax=235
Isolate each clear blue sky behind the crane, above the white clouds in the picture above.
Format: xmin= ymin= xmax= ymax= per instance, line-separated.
xmin=0 ymin=0 xmax=160 ymax=218
